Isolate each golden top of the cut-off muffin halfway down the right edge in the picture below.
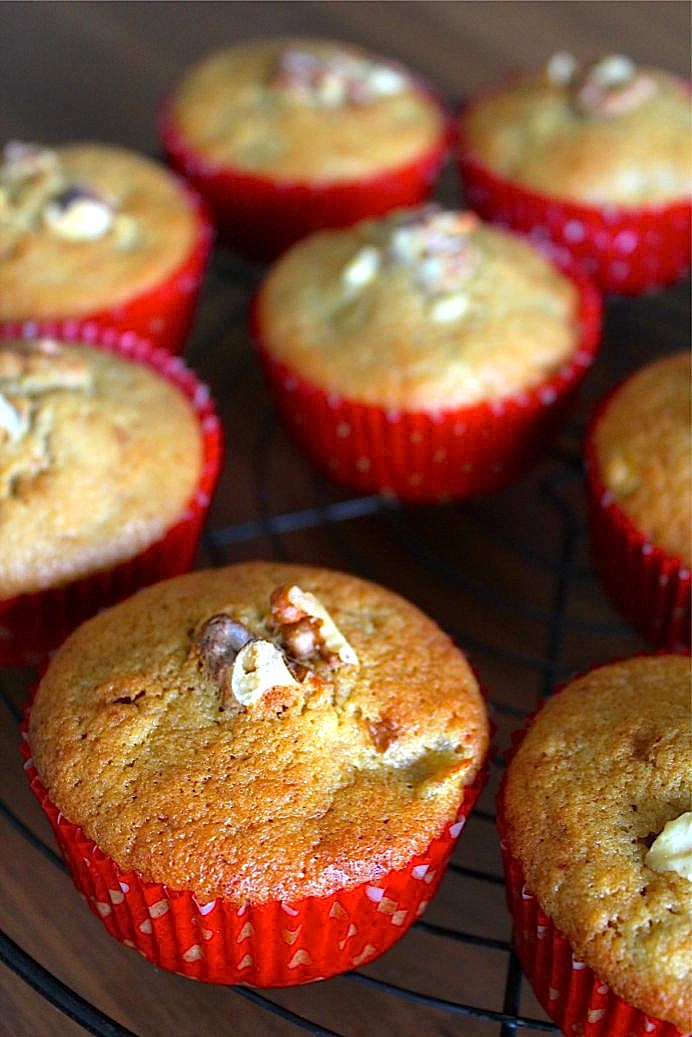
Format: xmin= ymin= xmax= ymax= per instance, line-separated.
xmin=593 ymin=353 xmax=692 ymax=565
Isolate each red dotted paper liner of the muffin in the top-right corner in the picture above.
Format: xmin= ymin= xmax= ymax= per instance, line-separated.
xmin=459 ymin=109 xmax=692 ymax=296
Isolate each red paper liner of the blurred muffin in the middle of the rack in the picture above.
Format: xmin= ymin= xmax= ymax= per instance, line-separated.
xmin=250 ymin=255 xmax=602 ymax=503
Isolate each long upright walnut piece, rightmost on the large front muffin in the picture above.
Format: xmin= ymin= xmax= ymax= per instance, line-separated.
xmin=272 ymin=585 xmax=358 ymax=666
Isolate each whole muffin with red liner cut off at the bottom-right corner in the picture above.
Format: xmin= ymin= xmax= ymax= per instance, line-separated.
xmin=498 ymin=655 xmax=692 ymax=1037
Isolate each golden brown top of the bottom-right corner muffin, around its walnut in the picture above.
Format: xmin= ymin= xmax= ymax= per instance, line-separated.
xmin=505 ymin=655 xmax=692 ymax=1031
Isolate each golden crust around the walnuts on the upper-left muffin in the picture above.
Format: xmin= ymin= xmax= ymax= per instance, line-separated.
xmin=0 ymin=143 xmax=198 ymax=320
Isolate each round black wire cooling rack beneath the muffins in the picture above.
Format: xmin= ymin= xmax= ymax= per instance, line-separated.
xmin=0 ymin=231 xmax=690 ymax=1037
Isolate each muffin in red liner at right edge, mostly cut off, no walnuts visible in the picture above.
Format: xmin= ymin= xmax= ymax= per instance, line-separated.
xmin=585 ymin=354 xmax=692 ymax=649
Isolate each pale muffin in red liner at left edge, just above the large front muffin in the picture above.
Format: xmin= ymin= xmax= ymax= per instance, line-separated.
xmin=0 ymin=326 xmax=221 ymax=665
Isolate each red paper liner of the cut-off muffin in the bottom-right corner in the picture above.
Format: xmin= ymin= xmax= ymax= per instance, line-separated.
xmin=497 ymin=689 xmax=684 ymax=1037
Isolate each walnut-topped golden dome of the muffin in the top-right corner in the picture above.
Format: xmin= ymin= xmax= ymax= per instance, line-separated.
xmin=462 ymin=54 xmax=692 ymax=206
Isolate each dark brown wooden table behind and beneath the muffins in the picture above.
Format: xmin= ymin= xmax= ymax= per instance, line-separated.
xmin=0 ymin=2 xmax=690 ymax=1037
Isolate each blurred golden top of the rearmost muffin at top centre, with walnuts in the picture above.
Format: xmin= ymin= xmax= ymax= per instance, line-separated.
xmin=171 ymin=39 xmax=445 ymax=181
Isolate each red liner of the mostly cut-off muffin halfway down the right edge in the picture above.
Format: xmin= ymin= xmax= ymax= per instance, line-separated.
xmin=584 ymin=387 xmax=692 ymax=651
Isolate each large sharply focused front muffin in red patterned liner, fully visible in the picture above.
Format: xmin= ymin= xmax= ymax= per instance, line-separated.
xmin=24 ymin=562 xmax=488 ymax=986
